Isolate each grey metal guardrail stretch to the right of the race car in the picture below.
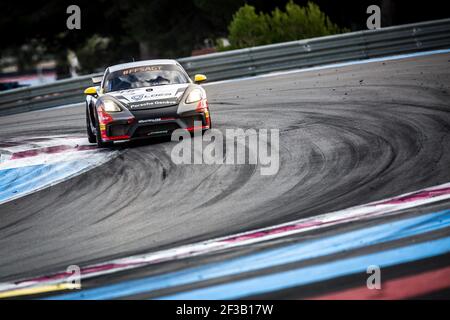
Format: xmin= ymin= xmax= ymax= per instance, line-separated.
xmin=179 ymin=19 xmax=450 ymax=80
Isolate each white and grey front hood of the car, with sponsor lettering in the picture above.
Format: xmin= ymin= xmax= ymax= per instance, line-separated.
xmin=107 ymin=83 xmax=189 ymax=110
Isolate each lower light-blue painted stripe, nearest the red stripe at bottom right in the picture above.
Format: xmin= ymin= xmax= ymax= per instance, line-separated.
xmin=160 ymin=237 xmax=450 ymax=300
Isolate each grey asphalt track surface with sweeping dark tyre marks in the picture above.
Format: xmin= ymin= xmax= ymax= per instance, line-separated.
xmin=0 ymin=54 xmax=450 ymax=296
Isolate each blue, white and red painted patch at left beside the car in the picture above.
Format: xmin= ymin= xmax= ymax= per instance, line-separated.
xmin=0 ymin=136 xmax=120 ymax=205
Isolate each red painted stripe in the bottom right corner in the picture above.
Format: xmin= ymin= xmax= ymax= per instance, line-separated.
xmin=310 ymin=266 xmax=450 ymax=300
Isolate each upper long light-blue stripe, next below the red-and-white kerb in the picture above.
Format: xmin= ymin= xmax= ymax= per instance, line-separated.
xmin=48 ymin=210 xmax=450 ymax=300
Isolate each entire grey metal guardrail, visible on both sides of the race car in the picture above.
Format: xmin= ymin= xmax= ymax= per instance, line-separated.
xmin=0 ymin=19 xmax=450 ymax=114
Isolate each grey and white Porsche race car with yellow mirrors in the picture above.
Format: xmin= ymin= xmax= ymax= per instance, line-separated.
xmin=84 ymin=60 xmax=211 ymax=147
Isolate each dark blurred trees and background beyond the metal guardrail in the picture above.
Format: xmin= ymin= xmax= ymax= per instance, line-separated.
xmin=0 ymin=0 xmax=448 ymax=90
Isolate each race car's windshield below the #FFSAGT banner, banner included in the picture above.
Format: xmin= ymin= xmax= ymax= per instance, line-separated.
xmin=104 ymin=65 xmax=189 ymax=92
